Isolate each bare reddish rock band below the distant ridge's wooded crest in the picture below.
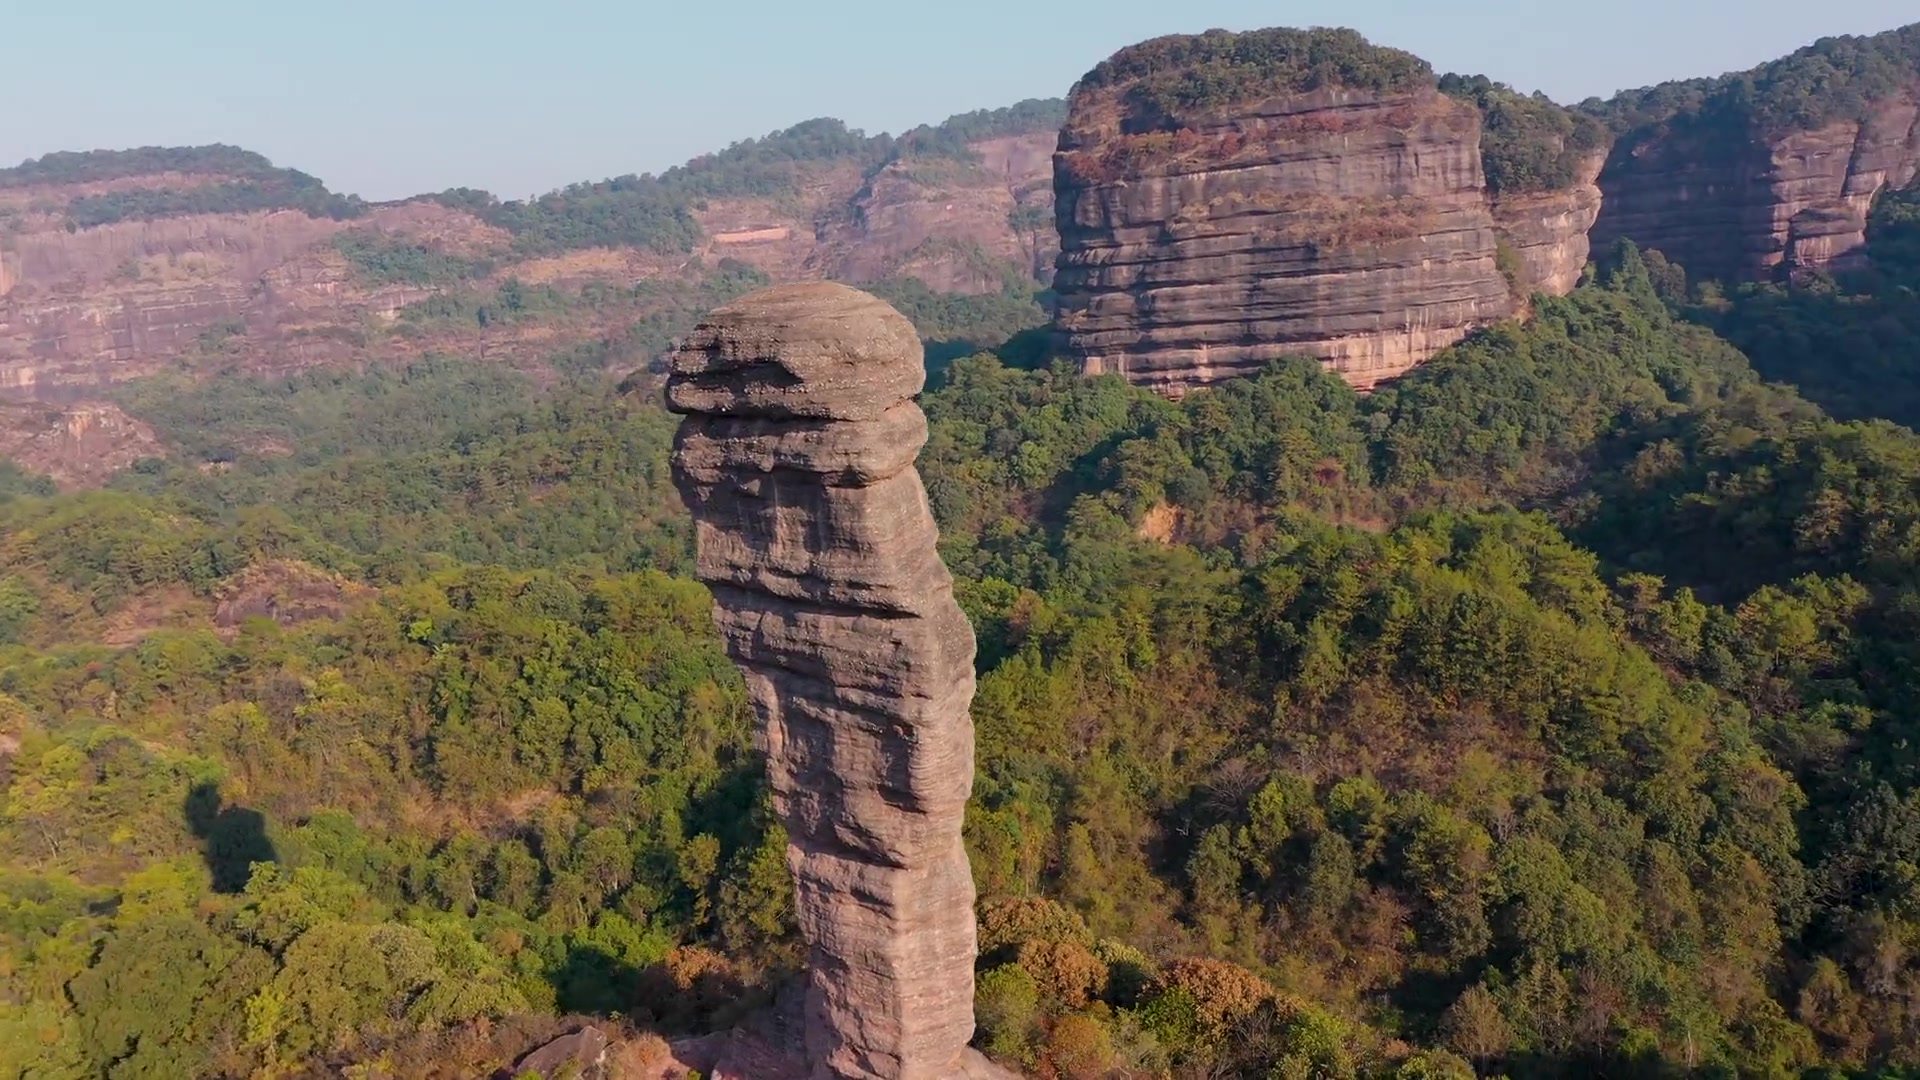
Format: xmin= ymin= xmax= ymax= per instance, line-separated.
xmin=0 ymin=133 xmax=1056 ymax=400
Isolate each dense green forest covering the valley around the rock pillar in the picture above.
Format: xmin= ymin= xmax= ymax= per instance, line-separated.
xmin=11 ymin=234 xmax=1920 ymax=1080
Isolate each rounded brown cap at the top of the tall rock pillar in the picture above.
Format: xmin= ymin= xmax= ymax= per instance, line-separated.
xmin=666 ymin=281 xmax=927 ymax=421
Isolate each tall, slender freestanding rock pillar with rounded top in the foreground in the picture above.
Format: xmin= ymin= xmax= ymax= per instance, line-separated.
xmin=666 ymin=282 xmax=983 ymax=1080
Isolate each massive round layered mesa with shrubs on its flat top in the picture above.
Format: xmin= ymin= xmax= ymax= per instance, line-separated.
xmin=1054 ymin=31 xmax=1515 ymax=392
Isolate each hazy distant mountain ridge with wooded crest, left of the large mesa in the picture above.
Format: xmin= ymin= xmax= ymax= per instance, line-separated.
xmin=0 ymin=100 xmax=1064 ymax=417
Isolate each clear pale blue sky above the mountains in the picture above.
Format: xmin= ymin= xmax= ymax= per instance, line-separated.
xmin=0 ymin=0 xmax=1920 ymax=198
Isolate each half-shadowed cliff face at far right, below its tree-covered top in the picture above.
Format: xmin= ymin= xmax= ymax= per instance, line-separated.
xmin=1594 ymin=79 xmax=1920 ymax=281
